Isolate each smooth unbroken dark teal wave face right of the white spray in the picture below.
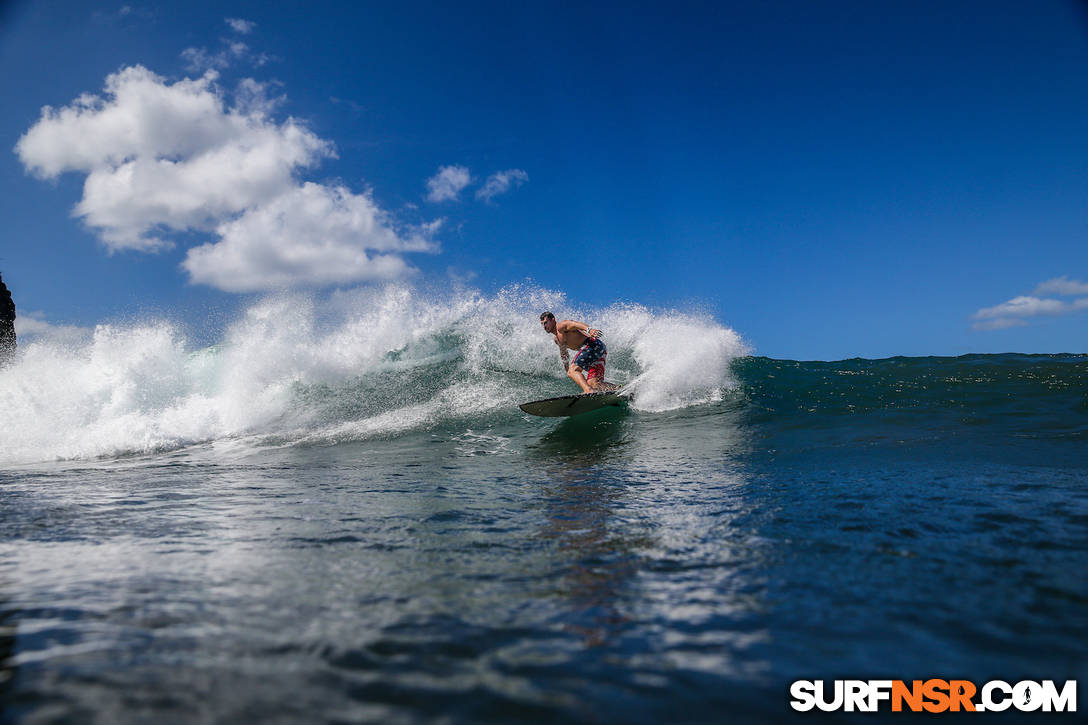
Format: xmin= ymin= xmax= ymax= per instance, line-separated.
xmin=734 ymin=355 xmax=1088 ymax=467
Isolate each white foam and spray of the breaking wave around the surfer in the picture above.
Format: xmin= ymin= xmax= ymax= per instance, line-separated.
xmin=0 ymin=285 xmax=747 ymax=465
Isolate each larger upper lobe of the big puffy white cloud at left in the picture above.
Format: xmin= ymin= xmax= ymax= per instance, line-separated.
xmin=15 ymin=66 xmax=334 ymax=251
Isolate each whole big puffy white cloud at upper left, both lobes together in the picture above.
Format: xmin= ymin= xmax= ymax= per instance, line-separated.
xmin=15 ymin=66 xmax=441 ymax=292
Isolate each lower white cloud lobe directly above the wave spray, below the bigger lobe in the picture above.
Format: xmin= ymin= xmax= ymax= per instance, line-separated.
xmin=182 ymin=183 xmax=435 ymax=292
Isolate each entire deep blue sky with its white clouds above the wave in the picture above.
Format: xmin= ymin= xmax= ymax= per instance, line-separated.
xmin=0 ymin=0 xmax=1088 ymax=359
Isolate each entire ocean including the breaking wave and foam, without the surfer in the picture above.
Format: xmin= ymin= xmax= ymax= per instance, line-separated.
xmin=0 ymin=286 xmax=1088 ymax=724
